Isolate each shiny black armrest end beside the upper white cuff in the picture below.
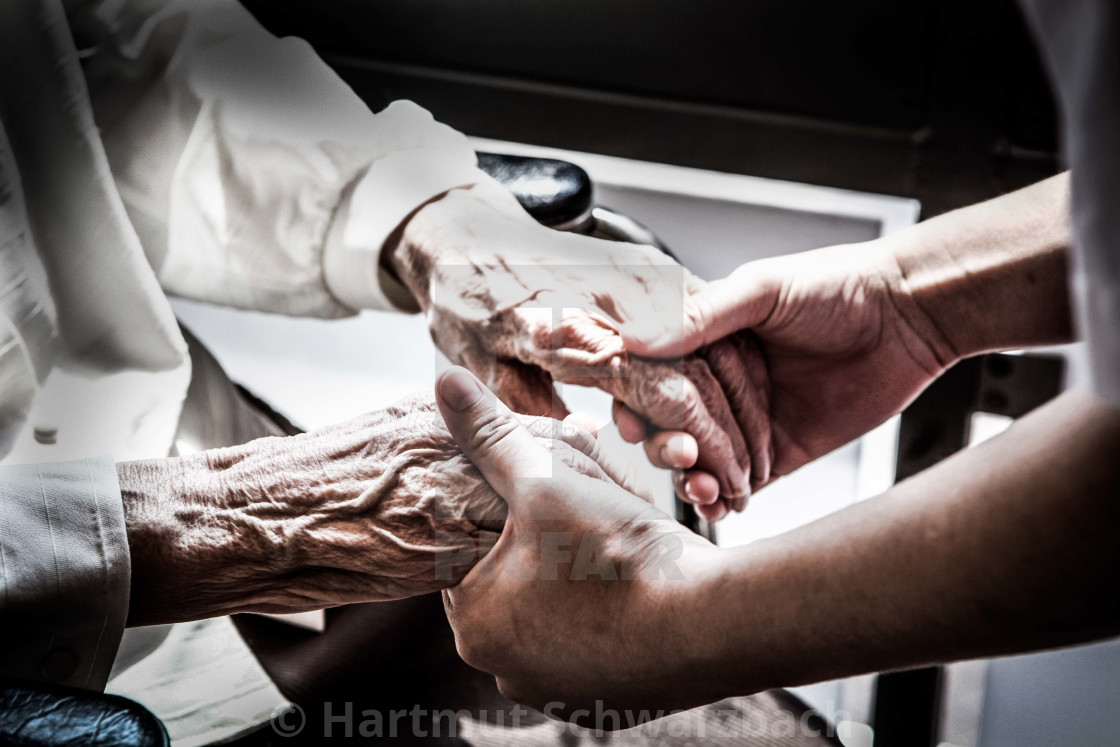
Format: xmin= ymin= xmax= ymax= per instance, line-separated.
xmin=478 ymin=153 xmax=594 ymax=231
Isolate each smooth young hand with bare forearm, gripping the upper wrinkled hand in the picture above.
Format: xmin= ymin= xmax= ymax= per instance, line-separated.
xmin=618 ymin=175 xmax=1072 ymax=519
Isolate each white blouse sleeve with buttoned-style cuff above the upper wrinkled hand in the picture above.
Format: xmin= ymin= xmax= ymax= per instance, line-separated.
xmin=71 ymin=0 xmax=485 ymax=317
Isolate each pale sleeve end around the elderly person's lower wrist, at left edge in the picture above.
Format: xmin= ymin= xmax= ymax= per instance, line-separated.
xmin=0 ymin=457 xmax=132 ymax=690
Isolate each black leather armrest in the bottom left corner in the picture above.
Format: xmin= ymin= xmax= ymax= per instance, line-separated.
xmin=0 ymin=680 xmax=170 ymax=747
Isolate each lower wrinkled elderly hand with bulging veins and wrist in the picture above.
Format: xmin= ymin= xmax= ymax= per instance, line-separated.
xmin=118 ymin=396 xmax=640 ymax=625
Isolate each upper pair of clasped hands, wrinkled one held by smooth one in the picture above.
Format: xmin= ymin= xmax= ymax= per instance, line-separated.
xmin=389 ymin=185 xmax=954 ymax=520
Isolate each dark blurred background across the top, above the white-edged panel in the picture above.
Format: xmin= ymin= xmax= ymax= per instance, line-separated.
xmin=245 ymin=0 xmax=1058 ymax=217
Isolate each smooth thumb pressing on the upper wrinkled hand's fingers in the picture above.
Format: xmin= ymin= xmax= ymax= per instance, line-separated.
xmin=622 ymin=272 xmax=774 ymax=358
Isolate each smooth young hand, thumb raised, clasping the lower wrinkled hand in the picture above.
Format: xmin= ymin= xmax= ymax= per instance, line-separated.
xmin=437 ymin=368 xmax=722 ymax=720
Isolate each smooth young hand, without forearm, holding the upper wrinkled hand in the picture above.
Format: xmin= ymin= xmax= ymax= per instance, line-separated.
xmin=619 ymin=242 xmax=958 ymax=517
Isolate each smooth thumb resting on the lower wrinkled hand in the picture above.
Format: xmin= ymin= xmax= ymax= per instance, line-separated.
xmin=436 ymin=366 xmax=557 ymax=508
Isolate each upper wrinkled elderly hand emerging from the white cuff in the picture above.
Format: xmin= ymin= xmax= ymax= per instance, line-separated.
xmin=389 ymin=185 xmax=750 ymax=501
